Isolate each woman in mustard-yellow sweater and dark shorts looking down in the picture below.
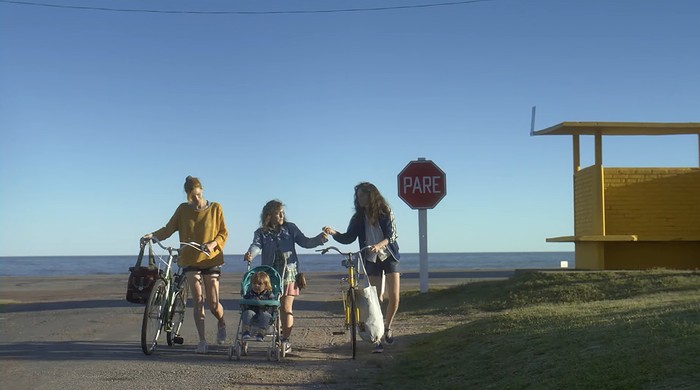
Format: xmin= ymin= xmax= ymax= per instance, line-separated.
xmin=143 ymin=176 xmax=228 ymax=353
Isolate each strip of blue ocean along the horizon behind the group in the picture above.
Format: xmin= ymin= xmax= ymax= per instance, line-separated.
xmin=0 ymin=252 xmax=574 ymax=276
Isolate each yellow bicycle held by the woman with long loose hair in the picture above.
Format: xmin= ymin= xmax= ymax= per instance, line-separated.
xmin=316 ymin=246 xmax=370 ymax=359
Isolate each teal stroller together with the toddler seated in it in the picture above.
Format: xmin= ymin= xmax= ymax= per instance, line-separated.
xmin=229 ymin=265 xmax=284 ymax=361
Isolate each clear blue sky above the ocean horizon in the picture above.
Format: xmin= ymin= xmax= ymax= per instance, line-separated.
xmin=0 ymin=0 xmax=700 ymax=256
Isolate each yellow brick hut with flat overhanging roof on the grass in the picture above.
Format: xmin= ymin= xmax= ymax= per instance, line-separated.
xmin=532 ymin=122 xmax=700 ymax=270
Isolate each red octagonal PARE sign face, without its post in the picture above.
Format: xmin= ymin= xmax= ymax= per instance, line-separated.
xmin=398 ymin=159 xmax=447 ymax=209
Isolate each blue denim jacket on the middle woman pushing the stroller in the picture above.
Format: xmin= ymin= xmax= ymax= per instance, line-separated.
xmin=248 ymin=222 xmax=325 ymax=266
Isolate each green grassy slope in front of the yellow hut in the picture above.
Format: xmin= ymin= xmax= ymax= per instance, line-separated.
xmin=373 ymin=270 xmax=700 ymax=389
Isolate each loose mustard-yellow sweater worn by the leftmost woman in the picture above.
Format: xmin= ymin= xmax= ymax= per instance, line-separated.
xmin=153 ymin=202 xmax=228 ymax=268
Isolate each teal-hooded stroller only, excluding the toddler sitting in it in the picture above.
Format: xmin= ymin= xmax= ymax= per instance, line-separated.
xmin=228 ymin=265 xmax=285 ymax=362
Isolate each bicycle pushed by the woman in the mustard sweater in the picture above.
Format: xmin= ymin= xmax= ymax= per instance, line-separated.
xmin=141 ymin=237 xmax=210 ymax=355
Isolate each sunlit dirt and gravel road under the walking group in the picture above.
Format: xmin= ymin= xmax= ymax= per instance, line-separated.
xmin=0 ymin=271 xmax=512 ymax=390
